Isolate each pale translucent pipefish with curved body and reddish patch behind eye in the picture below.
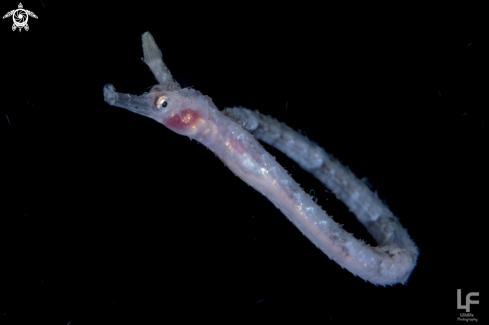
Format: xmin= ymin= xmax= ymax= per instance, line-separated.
xmin=104 ymin=33 xmax=418 ymax=285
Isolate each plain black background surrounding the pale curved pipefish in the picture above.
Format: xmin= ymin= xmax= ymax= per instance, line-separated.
xmin=0 ymin=0 xmax=489 ymax=324
